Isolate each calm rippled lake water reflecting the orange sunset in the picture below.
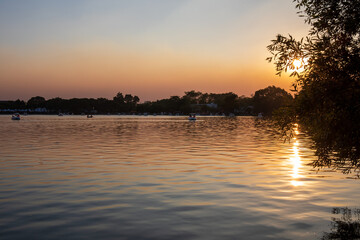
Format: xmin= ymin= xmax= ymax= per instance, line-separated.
xmin=0 ymin=116 xmax=360 ymax=240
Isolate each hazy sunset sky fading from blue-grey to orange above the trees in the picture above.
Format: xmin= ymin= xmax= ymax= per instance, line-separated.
xmin=0 ymin=0 xmax=309 ymax=102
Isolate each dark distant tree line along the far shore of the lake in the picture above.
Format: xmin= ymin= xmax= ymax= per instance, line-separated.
xmin=0 ymin=86 xmax=293 ymax=115
